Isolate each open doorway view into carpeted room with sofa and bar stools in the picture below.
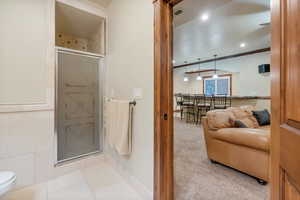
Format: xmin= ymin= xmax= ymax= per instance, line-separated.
xmin=173 ymin=0 xmax=271 ymax=200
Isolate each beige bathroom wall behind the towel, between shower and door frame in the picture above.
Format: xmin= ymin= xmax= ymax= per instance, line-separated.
xmin=106 ymin=0 xmax=154 ymax=195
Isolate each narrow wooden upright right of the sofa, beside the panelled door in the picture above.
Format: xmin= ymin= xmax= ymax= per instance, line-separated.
xmin=270 ymin=0 xmax=285 ymax=200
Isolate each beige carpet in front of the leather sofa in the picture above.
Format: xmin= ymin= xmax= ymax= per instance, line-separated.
xmin=174 ymin=118 xmax=269 ymax=200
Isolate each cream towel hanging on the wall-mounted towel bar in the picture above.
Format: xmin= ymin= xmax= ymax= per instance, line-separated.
xmin=107 ymin=100 xmax=132 ymax=156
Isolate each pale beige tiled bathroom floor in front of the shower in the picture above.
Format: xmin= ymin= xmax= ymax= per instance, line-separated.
xmin=1 ymin=163 xmax=142 ymax=200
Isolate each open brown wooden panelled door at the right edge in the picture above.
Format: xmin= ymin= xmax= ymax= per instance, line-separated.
xmin=271 ymin=0 xmax=300 ymax=200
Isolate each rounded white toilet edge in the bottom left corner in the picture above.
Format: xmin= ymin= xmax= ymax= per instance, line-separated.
xmin=0 ymin=171 xmax=17 ymax=199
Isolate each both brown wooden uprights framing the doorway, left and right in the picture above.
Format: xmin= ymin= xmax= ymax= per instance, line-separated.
xmin=153 ymin=0 xmax=285 ymax=200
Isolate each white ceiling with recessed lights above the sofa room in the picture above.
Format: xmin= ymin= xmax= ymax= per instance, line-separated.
xmin=174 ymin=0 xmax=271 ymax=65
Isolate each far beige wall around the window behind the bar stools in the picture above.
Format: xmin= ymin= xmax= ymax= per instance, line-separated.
xmin=174 ymin=52 xmax=271 ymax=96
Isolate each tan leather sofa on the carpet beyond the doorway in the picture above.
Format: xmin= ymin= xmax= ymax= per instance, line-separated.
xmin=202 ymin=107 xmax=270 ymax=184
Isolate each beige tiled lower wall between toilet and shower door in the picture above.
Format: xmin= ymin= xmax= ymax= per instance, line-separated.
xmin=0 ymin=111 xmax=53 ymax=187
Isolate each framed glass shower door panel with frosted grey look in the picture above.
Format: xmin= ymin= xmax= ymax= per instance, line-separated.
xmin=56 ymin=52 xmax=100 ymax=162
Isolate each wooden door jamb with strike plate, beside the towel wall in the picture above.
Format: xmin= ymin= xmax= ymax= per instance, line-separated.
xmin=153 ymin=0 xmax=181 ymax=200
